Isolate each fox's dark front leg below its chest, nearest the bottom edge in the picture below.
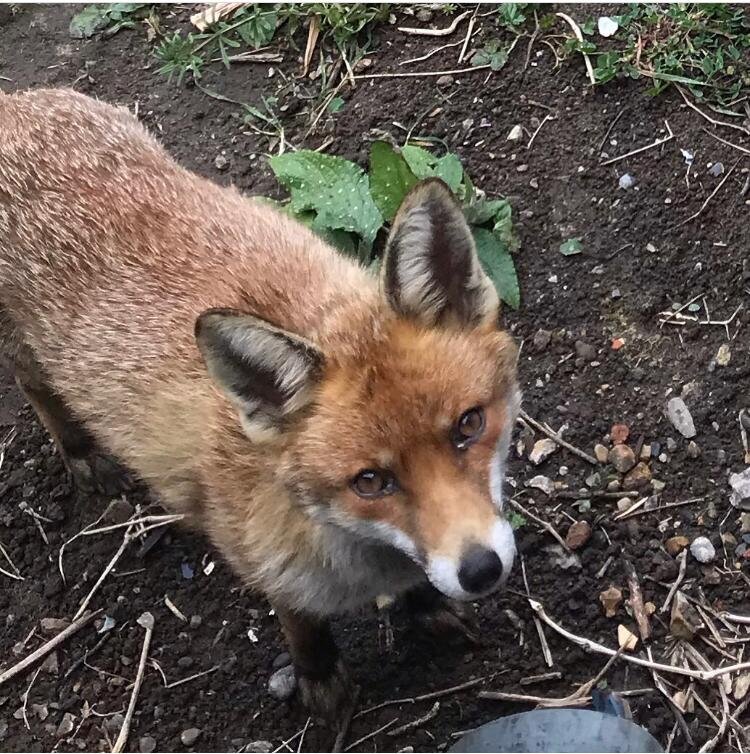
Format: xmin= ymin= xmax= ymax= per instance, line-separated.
xmin=276 ymin=607 xmax=353 ymax=723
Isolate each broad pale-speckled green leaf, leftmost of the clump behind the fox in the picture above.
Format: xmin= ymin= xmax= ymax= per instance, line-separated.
xmin=269 ymin=149 xmax=383 ymax=246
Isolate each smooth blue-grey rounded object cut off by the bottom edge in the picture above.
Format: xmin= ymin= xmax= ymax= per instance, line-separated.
xmin=449 ymin=709 xmax=663 ymax=754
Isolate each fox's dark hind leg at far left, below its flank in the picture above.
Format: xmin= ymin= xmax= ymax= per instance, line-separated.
xmin=14 ymin=346 xmax=130 ymax=495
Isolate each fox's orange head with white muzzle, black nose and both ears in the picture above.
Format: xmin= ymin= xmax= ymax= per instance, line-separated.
xmin=196 ymin=180 xmax=520 ymax=599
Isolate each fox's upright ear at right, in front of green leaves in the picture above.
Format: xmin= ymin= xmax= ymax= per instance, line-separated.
xmin=383 ymin=178 xmax=500 ymax=327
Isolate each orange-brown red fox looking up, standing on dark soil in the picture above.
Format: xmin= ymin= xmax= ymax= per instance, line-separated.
xmin=0 ymin=90 xmax=520 ymax=715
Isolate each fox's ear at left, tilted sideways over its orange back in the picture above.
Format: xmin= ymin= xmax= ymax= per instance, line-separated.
xmin=195 ymin=309 xmax=324 ymax=439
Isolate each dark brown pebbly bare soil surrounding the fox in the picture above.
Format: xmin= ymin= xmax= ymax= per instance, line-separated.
xmin=0 ymin=6 xmax=750 ymax=751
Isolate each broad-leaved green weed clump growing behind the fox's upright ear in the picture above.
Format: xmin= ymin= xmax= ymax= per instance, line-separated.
xmin=270 ymin=141 xmax=520 ymax=308
